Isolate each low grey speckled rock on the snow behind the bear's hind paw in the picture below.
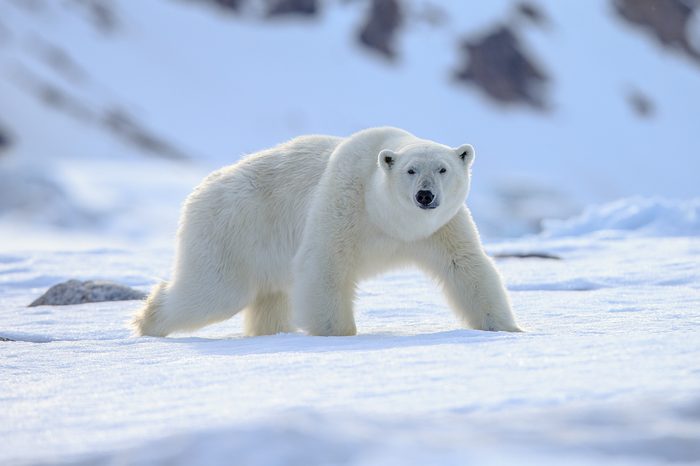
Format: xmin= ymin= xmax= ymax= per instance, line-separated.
xmin=29 ymin=280 xmax=146 ymax=307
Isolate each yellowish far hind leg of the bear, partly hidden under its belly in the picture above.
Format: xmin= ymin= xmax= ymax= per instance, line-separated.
xmin=244 ymin=291 xmax=293 ymax=336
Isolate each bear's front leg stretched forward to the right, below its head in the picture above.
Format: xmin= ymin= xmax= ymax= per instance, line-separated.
xmin=418 ymin=207 xmax=522 ymax=332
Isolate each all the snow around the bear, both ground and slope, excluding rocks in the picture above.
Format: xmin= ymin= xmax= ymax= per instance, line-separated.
xmin=0 ymin=0 xmax=700 ymax=465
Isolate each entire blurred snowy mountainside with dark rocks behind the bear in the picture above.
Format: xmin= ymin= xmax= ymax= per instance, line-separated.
xmin=0 ymin=0 xmax=700 ymax=249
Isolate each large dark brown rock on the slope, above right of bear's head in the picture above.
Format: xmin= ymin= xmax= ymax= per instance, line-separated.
xmin=455 ymin=26 xmax=549 ymax=110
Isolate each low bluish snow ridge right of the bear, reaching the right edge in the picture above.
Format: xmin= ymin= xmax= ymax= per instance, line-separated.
xmin=542 ymin=197 xmax=700 ymax=238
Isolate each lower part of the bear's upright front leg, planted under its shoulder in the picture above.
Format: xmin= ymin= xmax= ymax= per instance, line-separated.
xmin=292 ymin=237 xmax=357 ymax=336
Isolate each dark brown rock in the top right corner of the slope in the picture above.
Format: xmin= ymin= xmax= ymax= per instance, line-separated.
xmin=613 ymin=0 xmax=700 ymax=63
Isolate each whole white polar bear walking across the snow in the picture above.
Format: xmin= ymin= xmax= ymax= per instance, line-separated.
xmin=133 ymin=128 xmax=520 ymax=336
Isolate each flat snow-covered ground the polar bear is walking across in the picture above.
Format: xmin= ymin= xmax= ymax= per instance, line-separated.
xmin=0 ymin=200 xmax=700 ymax=465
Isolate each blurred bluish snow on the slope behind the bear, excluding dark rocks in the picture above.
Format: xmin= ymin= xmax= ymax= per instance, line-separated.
xmin=0 ymin=0 xmax=700 ymax=240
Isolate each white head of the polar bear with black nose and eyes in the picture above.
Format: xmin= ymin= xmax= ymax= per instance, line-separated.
xmin=366 ymin=141 xmax=474 ymax=239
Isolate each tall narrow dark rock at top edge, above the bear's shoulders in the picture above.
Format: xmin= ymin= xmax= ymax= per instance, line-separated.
xmin=358 ymin=0 xmax=403 ymax=59
